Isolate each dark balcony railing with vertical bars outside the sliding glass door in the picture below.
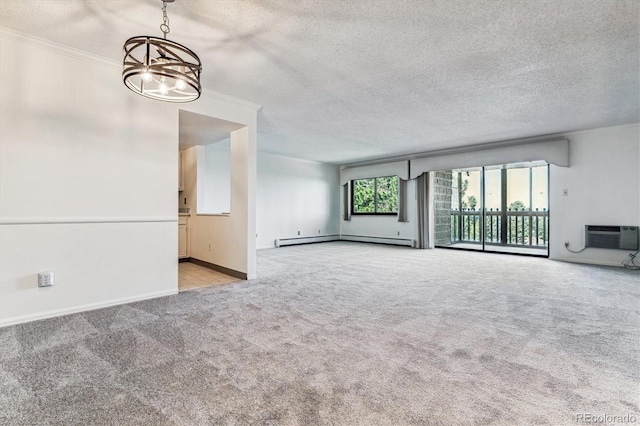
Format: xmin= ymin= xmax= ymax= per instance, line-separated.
xmin=451 ymin=209 xmax=549 ymax=247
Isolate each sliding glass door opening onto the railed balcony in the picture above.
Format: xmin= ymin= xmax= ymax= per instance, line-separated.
xmin=434 ymin=162 xmax=549 ymax=257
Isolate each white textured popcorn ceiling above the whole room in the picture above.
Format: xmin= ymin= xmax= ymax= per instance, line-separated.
xmin=0 ymin=0 xmax=640 ymax=163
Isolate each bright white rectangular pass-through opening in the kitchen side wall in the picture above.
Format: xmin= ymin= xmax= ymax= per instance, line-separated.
xmin=198 ymin=139 xmax=231 ymax=213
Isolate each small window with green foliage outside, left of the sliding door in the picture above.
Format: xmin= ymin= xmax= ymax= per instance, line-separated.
xmin=351 ymin=176 xmax=398 ymax=214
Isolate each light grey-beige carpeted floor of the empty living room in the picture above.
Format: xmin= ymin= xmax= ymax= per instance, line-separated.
xmin=0 ymin=242 xmax=640 ymax=425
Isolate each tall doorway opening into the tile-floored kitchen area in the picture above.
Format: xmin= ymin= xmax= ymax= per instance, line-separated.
xmin=177 ymin=110 xmax=246 ymax=292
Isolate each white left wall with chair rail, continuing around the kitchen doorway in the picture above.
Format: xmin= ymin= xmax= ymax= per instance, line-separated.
xmin=0 ymin=29 xmax=258 ymax=325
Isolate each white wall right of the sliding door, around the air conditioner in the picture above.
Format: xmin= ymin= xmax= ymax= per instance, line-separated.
xmin=549 ymin=124 xmax=640 ymax=266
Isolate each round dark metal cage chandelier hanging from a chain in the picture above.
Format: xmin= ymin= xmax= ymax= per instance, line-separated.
xmin=122 ymin=0 xmax=202 ymax=102
